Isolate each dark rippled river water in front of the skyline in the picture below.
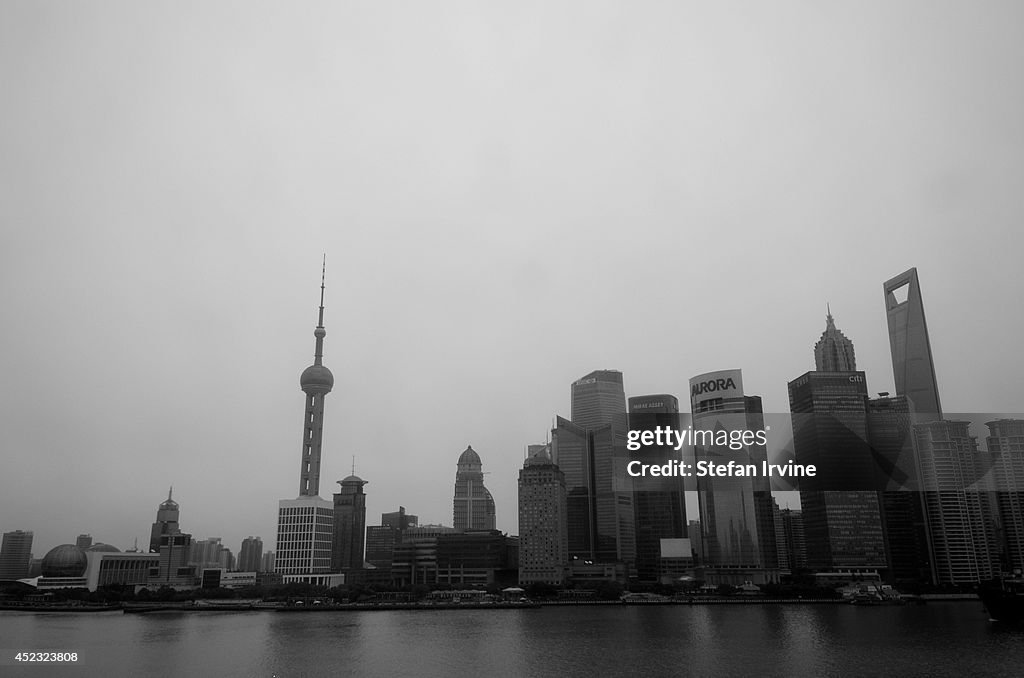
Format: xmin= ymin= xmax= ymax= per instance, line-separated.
xmin=0 ymin=602 xmax=1024 ymax=678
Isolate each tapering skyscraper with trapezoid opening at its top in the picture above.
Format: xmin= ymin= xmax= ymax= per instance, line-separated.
xmin=883 ymin=268 xmax=942 ymax=421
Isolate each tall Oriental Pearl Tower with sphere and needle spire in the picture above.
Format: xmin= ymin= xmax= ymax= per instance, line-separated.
xmin=299 ymin=258 xmax=334 ymax=497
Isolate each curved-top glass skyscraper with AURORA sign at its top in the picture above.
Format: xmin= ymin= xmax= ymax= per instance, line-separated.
xmin=690 ymin=370 xmax=778 ymax=585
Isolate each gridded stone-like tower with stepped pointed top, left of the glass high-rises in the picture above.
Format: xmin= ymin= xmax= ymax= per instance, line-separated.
xmin=519 ymin=444 xmax=568 ymax=586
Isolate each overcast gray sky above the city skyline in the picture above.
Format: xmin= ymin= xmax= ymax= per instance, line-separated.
xmin=0 ymin=0 xmax=1024 ymax=556
